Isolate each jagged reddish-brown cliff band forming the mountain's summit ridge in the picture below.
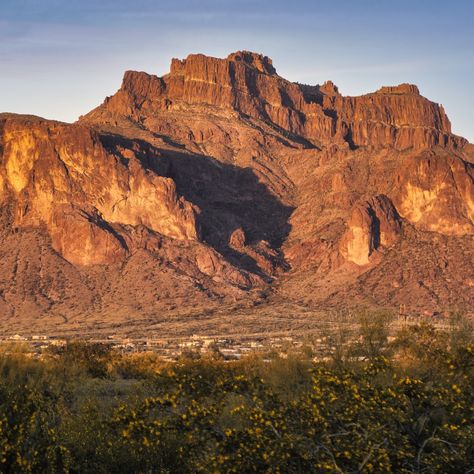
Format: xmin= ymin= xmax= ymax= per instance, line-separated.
xmin=84 ymin=51 xmax=465 ymax=149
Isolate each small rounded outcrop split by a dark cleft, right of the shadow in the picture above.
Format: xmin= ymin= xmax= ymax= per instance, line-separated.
xmin=339 ymin=195 xmax=401 ymax=265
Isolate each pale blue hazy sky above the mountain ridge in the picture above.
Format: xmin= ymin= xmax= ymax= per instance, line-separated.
xmin=0 ymin=0 xmax=474 ymax=142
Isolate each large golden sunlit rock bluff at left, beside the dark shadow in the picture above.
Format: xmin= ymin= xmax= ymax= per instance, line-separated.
xmin=0 ymin=113 xmax=199 ymax=265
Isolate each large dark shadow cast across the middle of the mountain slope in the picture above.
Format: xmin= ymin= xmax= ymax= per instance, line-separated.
xmin=102 ymin=131 xmax=294 ymax=274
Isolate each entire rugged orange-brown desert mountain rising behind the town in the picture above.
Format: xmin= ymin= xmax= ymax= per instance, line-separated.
xmin=0 ymin=51 xmax=474 ymax=331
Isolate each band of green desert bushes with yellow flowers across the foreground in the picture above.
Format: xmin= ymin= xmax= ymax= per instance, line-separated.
xmin=0 ymin=313 xmax=474 ymax=473
